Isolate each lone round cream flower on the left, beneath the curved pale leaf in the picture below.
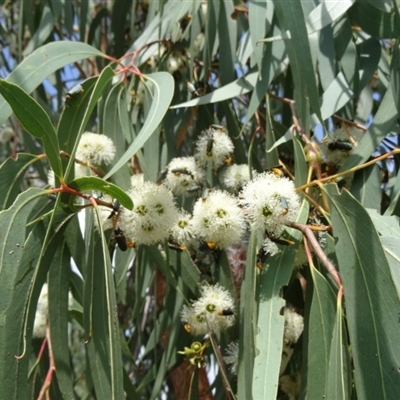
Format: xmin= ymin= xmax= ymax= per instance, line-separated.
xmin=75 ymin=132 xmax=116 ymax=165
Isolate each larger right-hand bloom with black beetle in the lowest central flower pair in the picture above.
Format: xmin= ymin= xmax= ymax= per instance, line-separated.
xmin=192 ymin=284 xmax=235 ymax=333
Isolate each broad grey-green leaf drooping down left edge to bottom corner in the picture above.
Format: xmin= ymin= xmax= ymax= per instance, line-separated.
xmin=0 ymin=188 xmax=44 ymax=399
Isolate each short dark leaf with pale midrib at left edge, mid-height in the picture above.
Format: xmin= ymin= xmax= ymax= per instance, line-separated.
xmin=0 ymin=153 xmax=38 ymax=210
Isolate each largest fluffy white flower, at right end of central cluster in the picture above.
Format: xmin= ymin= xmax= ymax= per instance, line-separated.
xmin=240 ymin=172 xmax=300 ymax=236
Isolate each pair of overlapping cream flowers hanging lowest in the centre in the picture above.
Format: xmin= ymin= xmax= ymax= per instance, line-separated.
xmin=181 ymin=284 xmax=235 ymax=335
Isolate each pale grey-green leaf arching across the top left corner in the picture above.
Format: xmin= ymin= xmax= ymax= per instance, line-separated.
xmin=0 ymin=41 xmax=105 ymax=123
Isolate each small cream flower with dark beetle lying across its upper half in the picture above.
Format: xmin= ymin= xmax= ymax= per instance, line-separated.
xmin=165 ymin=157 xmax=204 ymax=195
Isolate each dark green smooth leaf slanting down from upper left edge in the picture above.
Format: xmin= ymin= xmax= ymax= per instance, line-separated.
xmin=0 ymin=79 xmax=63 ymax=177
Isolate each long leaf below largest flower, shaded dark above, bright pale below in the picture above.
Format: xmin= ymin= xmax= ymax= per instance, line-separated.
xmin=253 ymin=201 xmax=308 ymax=399
